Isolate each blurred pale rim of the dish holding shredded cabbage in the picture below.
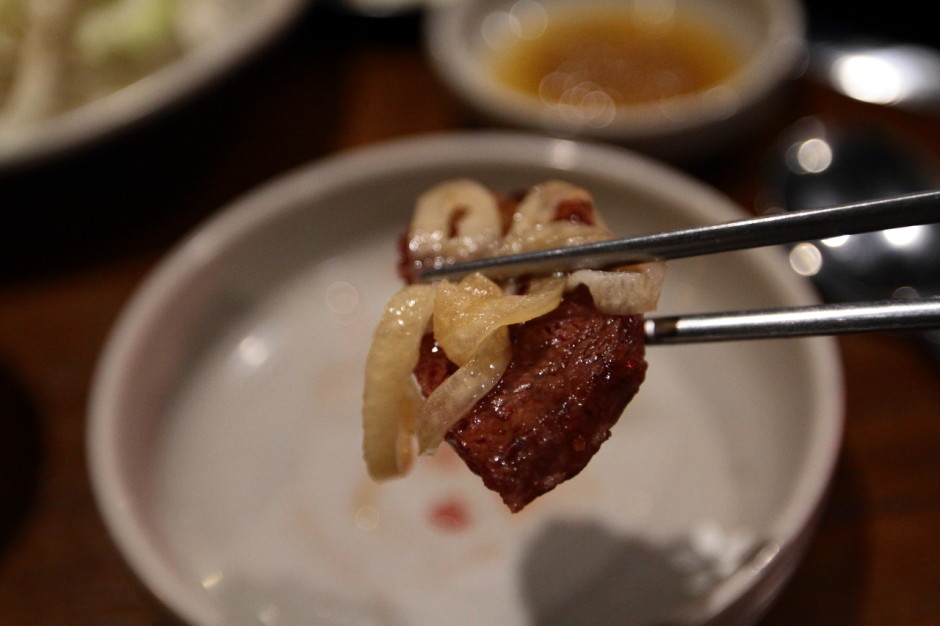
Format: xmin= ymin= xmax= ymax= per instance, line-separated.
xmin=0 ymin=0 xmax=309 ymax=172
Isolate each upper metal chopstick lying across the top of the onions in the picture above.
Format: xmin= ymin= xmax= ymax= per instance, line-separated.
xmin=421 ymin=191 xmax=940 ymax=281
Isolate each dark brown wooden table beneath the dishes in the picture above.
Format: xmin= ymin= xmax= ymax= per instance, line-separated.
xmin=0 ymin=6 xmax=940 ymax=625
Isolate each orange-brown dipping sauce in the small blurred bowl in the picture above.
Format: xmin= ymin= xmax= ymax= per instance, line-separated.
xmin=491 ymin=6 xmax=741 ymax=109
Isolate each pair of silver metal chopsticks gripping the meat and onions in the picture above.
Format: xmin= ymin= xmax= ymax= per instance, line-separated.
xmin=421 ymin=191 xmax=940 ymax=345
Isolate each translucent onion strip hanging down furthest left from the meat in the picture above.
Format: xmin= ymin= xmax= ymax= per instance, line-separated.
xmin=362 ymin=285 xmax=434 ymax=479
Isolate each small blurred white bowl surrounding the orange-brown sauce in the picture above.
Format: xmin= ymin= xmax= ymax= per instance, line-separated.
xmin=425 ymin=0 xmax=806 ymax=161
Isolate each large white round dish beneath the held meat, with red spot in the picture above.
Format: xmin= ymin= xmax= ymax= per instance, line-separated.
xmin=88 ymin=133 xmax=843 ymax=625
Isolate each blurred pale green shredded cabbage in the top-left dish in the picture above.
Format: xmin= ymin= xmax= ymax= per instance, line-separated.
xmin=0 ymin=0 xmax=261 ymax=135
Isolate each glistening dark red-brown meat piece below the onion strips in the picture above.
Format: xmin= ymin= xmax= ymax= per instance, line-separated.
xmin=415 ymin=286 xmax=646 ymax=512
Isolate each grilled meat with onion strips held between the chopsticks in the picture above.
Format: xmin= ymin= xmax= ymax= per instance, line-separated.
xmin=363 ymin=179 xmax=665 ymax=512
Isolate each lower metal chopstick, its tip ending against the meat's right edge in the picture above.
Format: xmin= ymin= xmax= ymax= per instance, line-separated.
xmin=644 ymin=297 xmax=940 ymax=345
